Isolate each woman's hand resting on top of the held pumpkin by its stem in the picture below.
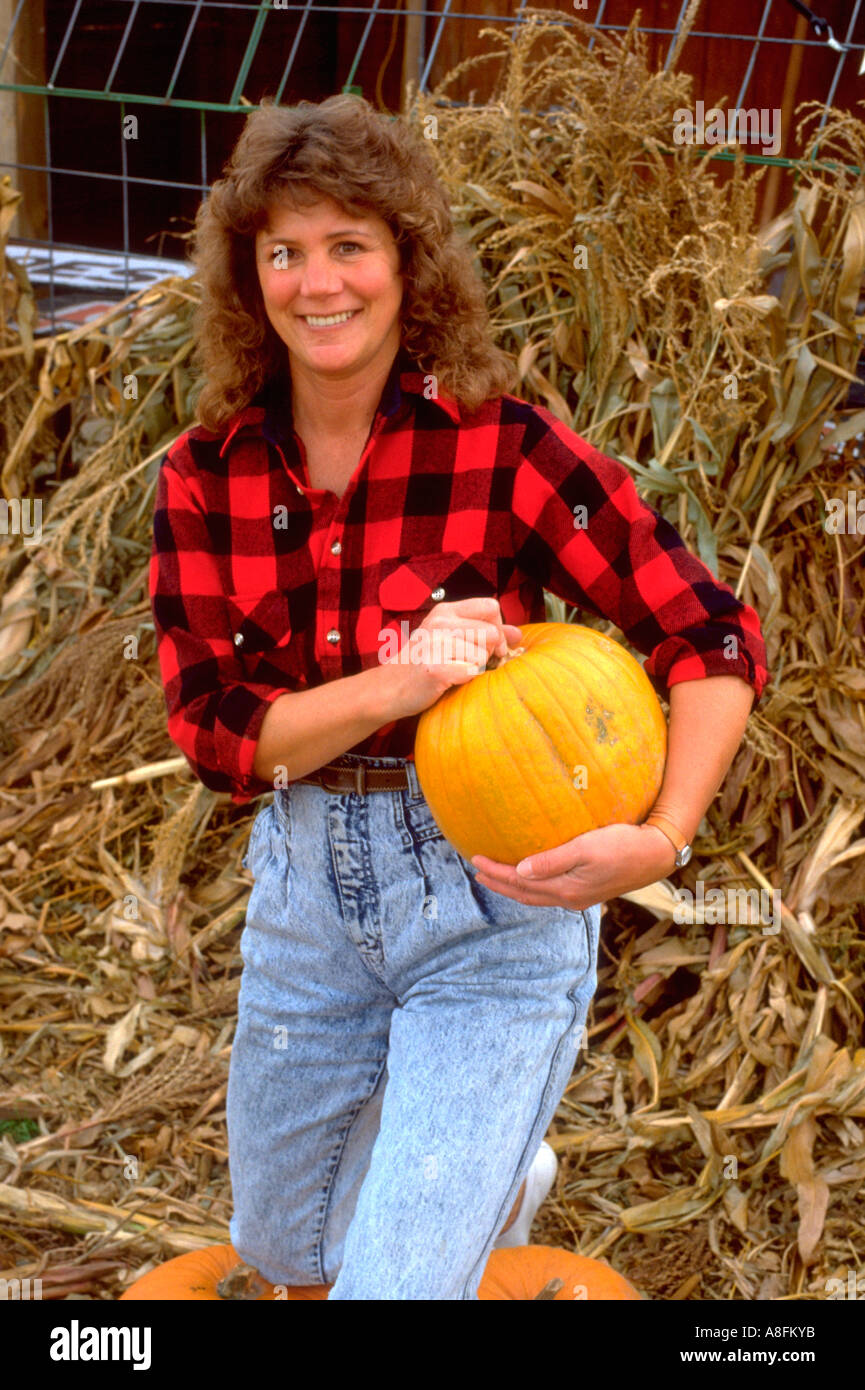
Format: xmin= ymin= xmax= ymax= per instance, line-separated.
xmin=381 ymin=598 xmax=523 ymax=719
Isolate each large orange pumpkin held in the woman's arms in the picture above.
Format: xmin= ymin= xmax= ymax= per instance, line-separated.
xmin=414 ymin=623 xmax=666 ymax=865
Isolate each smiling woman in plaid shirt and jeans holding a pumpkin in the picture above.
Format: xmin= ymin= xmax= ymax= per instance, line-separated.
xmin=152 ymin=96 xmax=768 ymax=1300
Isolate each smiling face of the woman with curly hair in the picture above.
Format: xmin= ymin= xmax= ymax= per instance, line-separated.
xmin=256 ymin=199 xmax=403 ymax=378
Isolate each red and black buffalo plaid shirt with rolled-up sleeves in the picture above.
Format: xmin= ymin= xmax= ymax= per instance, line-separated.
xmin=150 ymin=341 xmax=769 ymax=805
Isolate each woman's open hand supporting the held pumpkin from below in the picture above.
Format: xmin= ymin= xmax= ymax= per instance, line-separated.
xmin=471 ymin=826 xmax=676 ymax=910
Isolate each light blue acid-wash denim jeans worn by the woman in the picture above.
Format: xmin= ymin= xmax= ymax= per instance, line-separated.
xmin=227 ymin=755 xmax=601 ymax=1300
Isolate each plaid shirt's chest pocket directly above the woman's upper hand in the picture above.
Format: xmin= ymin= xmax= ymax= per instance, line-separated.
xmin=378 ymin=550 xmax=499 ymax=621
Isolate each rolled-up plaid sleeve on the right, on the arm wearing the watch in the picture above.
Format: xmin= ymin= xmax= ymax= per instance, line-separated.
xmin=513 ymin=410 xmax=769 ymax=708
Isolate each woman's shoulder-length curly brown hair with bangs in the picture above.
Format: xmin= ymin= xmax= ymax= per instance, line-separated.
xmin=192 ymin=93 xmax=515 ymax=434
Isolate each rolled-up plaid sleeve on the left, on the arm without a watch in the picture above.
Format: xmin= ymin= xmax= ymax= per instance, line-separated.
xmin=150 ymin=450 xmax=288 ymax=805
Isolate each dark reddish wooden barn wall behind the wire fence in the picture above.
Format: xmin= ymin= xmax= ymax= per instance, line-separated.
xmin=19 ymin=0 xmax=865 ymax=256
